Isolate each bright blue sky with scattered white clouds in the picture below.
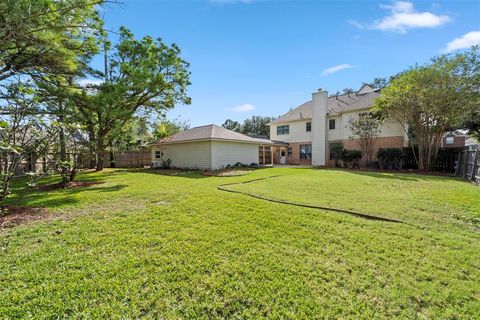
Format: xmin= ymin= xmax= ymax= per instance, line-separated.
xmin=96 ymin=0 xmax=480 ymax=126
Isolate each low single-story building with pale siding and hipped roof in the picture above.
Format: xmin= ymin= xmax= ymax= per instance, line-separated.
xmin=152 ymin=124 xmax=282 ymax=170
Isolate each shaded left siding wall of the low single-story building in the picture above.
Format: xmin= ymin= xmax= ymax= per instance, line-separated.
xmin=152 ymin=141 xmax=211 ymax=169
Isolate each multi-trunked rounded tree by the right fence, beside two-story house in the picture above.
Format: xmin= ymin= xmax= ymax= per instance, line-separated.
xmin=374 ymin=48 xmax=480 ymax=170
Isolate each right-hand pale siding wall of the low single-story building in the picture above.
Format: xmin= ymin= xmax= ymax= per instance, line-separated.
xmin=212 ymin=141 xmax=259 ymax=169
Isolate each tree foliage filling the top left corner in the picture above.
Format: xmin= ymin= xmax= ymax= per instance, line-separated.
xmin=0 ymin=0 xmax=104 ymax=81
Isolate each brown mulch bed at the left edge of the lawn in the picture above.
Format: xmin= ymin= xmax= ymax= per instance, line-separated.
xmin=0 ymin=206 xmax=50 ymax=230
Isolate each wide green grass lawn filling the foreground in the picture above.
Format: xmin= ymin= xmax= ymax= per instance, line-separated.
xmin=0 ymin=168 xmax=480 ymax=319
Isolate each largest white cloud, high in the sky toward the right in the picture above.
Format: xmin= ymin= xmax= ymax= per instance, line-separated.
xmin=348 ymin=1 xmax=452 ymax=33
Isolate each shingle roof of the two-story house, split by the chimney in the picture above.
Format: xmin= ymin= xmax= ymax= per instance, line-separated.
xmin=271 ymin=87 xmax=380 ymax=124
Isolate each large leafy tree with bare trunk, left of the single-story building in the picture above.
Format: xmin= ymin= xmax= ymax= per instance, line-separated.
xmin=79 ymin=27 xmax=190 ymax=170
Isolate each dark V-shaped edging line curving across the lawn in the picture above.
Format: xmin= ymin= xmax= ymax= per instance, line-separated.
xmin=217 ymin=175 xmax=404 ymax=223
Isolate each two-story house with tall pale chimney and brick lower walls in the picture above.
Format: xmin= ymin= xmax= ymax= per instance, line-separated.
xmin=270 ymin=85 xmax=408 ymax=166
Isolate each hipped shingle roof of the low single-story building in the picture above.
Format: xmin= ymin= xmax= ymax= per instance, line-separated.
xmin=154 ymin=124 xmax=274 ymax=144
